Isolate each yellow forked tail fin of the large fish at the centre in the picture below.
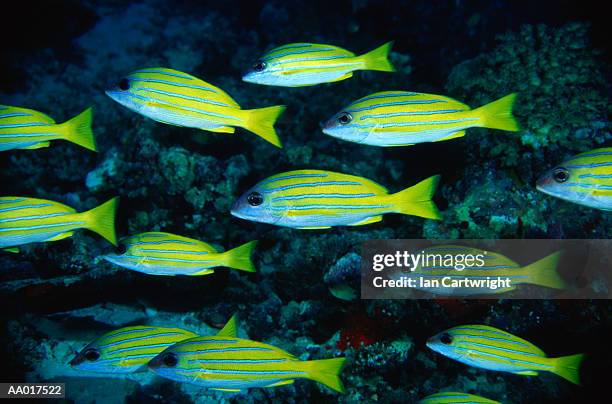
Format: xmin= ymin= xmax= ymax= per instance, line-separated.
xmin=388 ymin=175 xmax=442 ymax=220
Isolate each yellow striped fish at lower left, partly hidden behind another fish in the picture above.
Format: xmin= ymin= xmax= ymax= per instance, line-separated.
xmin=69 ymin=315 xmax=237 ymax=374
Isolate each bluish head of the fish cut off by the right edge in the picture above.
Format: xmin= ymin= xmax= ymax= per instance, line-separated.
xmin=536 ymin=164 xmax=589 ymax=204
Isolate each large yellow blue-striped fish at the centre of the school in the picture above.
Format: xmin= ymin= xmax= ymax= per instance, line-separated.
xmin=231 ymin=170 xmax=440 ymax=229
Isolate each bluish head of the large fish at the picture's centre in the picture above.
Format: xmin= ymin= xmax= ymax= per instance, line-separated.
xmin=230 ymin=181 xmax=282 ymax=224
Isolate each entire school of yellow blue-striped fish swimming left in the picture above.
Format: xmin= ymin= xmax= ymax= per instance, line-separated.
xmin=0 ymin=35 xmax=600 ymax=404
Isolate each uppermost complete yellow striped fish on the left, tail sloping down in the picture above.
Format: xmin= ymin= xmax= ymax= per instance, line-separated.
xmin=106 ymin=67 xmax=285 ymax=147
